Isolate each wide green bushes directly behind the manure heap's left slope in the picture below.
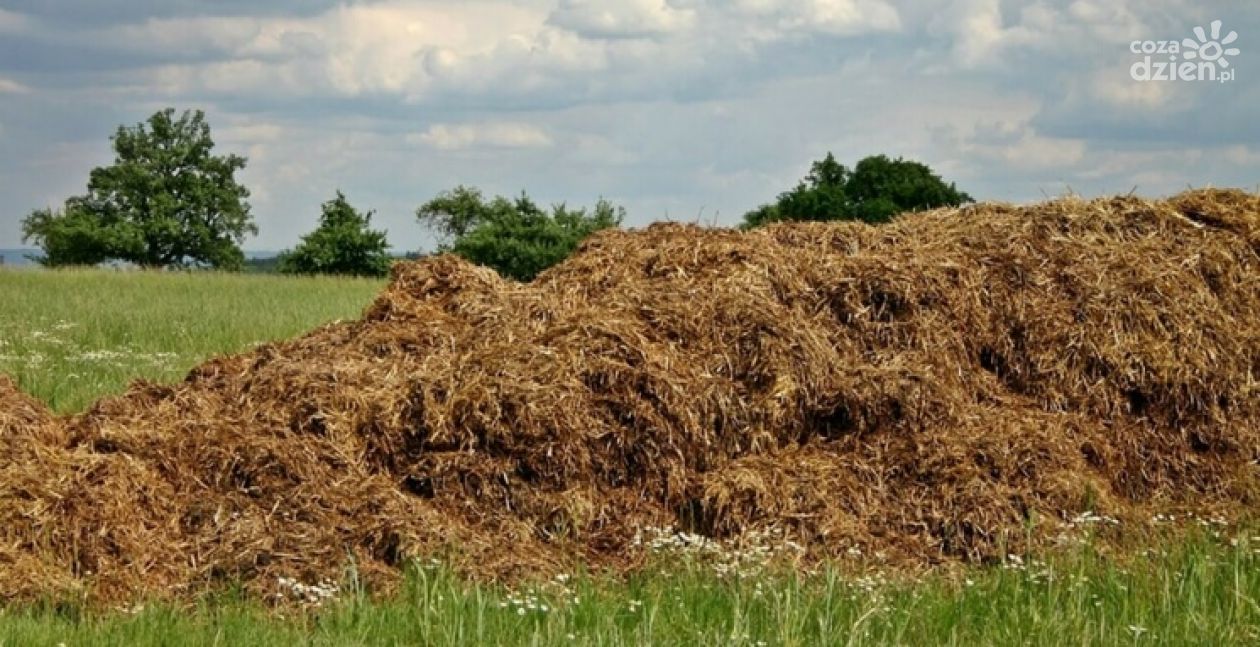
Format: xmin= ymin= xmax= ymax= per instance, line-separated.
xmin=416 ymin=187 xmax=625 ymax=281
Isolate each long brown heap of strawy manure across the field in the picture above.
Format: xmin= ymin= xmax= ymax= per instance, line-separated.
xmin=0 ymin=190 xmax=1260 ymax=602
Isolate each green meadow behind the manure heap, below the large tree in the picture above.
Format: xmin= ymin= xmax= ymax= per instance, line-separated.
xmin=0 ymin=270 xmax=384 ymax=412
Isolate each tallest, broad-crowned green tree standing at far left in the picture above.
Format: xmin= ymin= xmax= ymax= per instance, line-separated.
xmin=23 ymin=108 xmax=258 ymax=269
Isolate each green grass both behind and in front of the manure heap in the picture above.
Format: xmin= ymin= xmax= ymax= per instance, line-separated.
xmin=0 ymin=266 xmax=1260 ymax=646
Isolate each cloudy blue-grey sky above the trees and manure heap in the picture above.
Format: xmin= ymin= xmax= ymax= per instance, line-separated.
xmin=0 ymin=0 xmax=1260 ymax=252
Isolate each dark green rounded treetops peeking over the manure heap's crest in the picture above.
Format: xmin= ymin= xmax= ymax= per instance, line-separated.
xmin=743 ymin=153 xmax=973 ymax=228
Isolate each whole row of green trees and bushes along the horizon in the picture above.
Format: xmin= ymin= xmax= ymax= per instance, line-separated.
xmin=23 ymin=108 xmax=971 ymax=280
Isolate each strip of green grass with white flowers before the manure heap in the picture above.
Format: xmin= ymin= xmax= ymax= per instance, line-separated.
xmin=0 ymin=535 xmax=1260 ymax=646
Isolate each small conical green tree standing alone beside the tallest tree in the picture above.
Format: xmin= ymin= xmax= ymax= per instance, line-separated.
xmin=277 ymin=192 xmax=391 ymax=276
